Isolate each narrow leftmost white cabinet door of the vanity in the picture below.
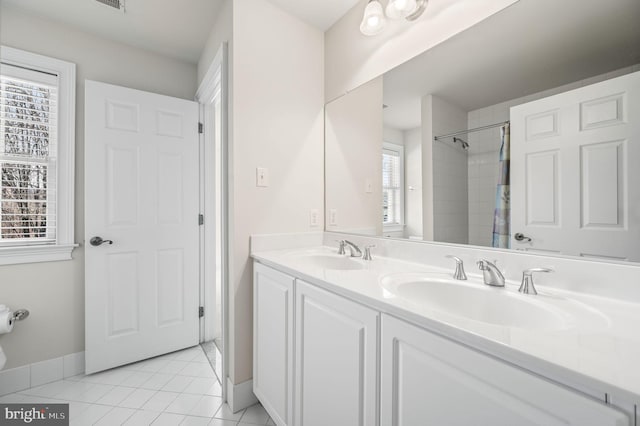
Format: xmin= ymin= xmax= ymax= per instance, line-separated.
xmin=253 ymin=263 xmax=294 ymax=426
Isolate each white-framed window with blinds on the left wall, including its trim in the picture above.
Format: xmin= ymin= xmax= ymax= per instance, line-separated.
xmin=0 ymin=46 xmax=75 ymax=264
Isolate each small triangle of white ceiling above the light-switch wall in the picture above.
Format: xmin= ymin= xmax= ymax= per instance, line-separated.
xmin=269 ymin=0 xmax=364 ymax=31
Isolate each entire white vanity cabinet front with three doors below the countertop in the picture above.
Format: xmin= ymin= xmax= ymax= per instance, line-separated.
xmin=253 ymin=262 xmax=635 ymax=426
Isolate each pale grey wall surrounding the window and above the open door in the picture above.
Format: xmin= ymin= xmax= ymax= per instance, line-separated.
xmin=0 ymin=4 xmax=196 ymax=368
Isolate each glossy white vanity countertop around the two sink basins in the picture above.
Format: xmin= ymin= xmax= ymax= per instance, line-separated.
xmin=252 ymin=246 xmax=640 ymax=404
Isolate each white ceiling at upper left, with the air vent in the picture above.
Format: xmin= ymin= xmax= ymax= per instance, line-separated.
xmin=1 ymin=0 xmax=222 ymax=63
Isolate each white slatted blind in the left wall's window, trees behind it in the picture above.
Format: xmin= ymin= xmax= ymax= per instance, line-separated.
xmin=0 ymin=63 xmax=58 ymax=246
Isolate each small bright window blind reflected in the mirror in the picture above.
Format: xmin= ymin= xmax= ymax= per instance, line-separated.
xmin=382 ymin=149 xmax=402 ymax=225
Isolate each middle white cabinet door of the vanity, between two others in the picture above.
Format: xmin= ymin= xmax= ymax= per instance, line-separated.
xmin=294 ymin=280 xmax=378 ymax=426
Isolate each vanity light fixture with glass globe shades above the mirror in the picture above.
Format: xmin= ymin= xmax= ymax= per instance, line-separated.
xmin=360 ymin=0 xmax=428 ymax=36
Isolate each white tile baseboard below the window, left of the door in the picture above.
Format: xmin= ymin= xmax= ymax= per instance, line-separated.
xmin=0 ymin=352 xmax=84 ymax=396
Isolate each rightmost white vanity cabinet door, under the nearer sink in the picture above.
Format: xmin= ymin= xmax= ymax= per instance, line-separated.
xmin=380 ymin=315 xmax=629 ymax=426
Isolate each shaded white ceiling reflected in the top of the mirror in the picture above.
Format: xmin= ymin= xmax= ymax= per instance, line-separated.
xmin=384 ymin=0 xmax=640 ymax=129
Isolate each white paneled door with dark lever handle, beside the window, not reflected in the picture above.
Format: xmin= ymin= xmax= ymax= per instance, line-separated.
xmin=85 ymin=81 xmax=199 ymax=373
